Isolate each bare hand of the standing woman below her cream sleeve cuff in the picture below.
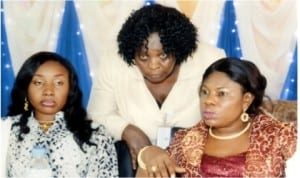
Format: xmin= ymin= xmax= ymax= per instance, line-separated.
xmin=122 ymin=124 xmax=151 ymax=169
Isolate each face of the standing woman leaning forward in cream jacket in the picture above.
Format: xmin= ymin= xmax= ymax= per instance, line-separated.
xmin=135 ymin=33 xmax=176 ymax=83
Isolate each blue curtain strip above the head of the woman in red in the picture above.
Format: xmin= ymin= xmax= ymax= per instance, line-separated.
xmin=217 ymin=0 xmax=242 ymax=58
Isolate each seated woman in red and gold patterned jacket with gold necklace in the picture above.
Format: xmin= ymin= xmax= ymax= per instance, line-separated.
xmin=137 ymin=58 xmax=297 ymax=177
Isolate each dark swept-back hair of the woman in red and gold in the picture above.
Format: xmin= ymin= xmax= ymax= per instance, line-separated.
xmin=202 ymin=57 xmax=267 ymax=115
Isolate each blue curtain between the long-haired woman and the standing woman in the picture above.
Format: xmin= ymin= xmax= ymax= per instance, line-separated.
xmin=56 ymin=1 xmax=91 ymax=107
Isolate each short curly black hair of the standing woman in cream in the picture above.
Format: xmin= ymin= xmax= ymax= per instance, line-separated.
xmin=117 ymin=4 xmax=198 ymax=65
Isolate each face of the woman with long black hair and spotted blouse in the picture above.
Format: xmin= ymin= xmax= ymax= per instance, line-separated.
xmin=28 ymin=61 xmax=69 ymax=120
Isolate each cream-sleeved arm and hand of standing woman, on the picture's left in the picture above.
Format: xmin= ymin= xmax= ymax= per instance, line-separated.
xmin=88 ymin=56 xmax=151 ymax=169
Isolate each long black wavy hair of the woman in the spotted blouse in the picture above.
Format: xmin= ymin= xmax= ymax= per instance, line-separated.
xmin=7 ymin=52 xmax=94 ymax=149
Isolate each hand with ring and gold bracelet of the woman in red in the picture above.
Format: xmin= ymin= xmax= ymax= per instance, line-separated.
xmin=136 ymin=146 xmax=185 ymax=177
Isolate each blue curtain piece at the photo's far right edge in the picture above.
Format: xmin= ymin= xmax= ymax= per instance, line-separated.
xmin=280 ymin=45 xmax=298 ymax=100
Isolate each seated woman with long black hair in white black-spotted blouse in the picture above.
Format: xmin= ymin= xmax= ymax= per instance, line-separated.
xmin=4 ymin=52 xmax=118 ymax=177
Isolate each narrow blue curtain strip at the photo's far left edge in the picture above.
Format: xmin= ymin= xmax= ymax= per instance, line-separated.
xmin=1 ymin=1 xmax=15 ymax=117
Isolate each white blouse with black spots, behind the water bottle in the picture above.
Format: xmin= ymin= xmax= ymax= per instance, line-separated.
xmin=7 ymin=112 xmax=118 ymax=177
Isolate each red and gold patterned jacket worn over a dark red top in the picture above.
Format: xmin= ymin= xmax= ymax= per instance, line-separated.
xmin=167 ymin=114 xmax=297 ymax=177
